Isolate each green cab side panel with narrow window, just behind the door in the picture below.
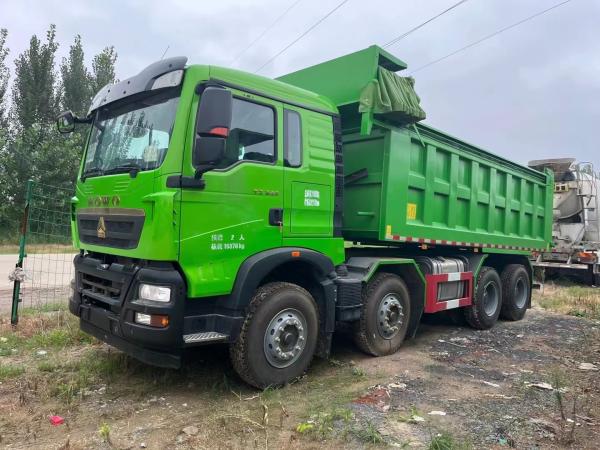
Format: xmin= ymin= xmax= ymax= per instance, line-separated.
xmin=283 ymin=105 xmax=335 ymax=238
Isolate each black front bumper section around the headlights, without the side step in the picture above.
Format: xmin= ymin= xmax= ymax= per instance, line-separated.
xmin=69 ymin=255 xmax=185 ymax=368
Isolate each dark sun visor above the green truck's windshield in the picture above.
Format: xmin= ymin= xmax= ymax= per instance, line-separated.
xmin=88 ymin=56 xmax=187 ymax=115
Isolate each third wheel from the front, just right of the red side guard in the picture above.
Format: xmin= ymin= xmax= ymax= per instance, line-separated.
xmin=464 ymin=266 xmax=502 ymax=330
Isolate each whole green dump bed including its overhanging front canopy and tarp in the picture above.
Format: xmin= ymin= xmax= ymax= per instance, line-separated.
xmin=280 ymin=46 xmax=553 ymax=251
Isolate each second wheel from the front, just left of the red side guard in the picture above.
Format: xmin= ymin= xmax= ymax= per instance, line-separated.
xmin=353 ymin=273 xmax=410 ymax=356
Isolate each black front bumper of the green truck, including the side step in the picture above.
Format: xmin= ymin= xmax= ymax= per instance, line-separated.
xmin=69 ymin=254 xmax=243 ymax=368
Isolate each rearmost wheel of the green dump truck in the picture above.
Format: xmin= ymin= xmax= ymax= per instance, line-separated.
xmin=500 ymin=264 xmax=531 ymax=321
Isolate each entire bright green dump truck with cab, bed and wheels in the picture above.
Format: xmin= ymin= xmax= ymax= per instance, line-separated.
xmin=58 ymin=46 xmax=553 ymax=387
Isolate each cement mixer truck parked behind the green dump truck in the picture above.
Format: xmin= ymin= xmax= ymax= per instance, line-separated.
xmin=529 ymin=158 xmax=600 ymax=285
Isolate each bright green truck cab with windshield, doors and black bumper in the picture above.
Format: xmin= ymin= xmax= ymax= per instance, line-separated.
xmin=70 ymin=58 xmax=344 ymax=378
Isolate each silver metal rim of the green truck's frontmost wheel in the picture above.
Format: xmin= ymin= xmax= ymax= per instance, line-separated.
xmin=264 ymin=308 xmax=306 ymax=369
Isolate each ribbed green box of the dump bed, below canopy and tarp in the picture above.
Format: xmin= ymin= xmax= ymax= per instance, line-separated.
xmin=344 ymin=125 xmax=552 ymax=250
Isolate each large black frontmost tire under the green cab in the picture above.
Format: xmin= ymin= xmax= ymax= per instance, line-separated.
xmin=229 ymin=282 xmax=319 ymax=389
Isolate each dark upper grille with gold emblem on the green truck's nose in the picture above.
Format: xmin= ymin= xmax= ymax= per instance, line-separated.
xmin=77 ymin=208 xmax=144 ymax=249
